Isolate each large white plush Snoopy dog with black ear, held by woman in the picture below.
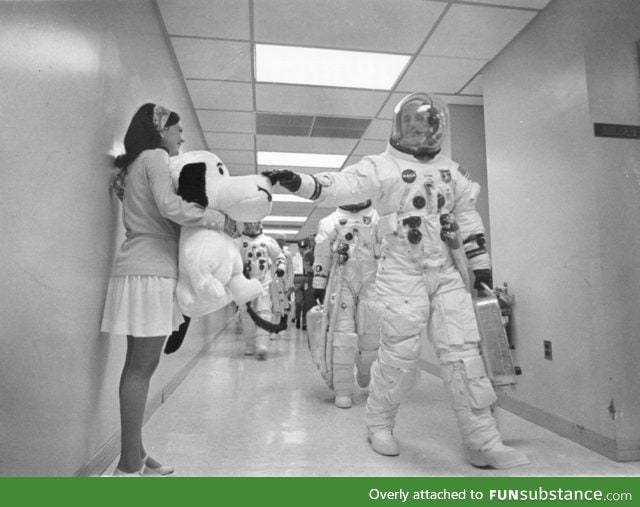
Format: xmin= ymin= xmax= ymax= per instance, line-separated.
xmin=171 ymin=151 xmax=272 ymax=317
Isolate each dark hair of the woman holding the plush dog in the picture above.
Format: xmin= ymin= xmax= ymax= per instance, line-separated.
xmin=115 ymin=103 xmax=180 ymax=171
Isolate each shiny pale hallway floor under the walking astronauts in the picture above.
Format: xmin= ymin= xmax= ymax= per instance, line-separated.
xmin=105 ymin=319 xmax=640 ymax=477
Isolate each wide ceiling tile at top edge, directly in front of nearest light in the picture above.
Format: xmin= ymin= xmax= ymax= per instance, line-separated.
xmin=253 ymin=0 xmax=446 ymax=53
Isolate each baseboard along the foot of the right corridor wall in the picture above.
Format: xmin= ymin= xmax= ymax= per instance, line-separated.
xmin=420 ymin=359 xmax=640 ymax=461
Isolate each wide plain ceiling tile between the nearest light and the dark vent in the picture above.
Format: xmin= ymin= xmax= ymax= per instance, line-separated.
xmin=256 ymin=83 xmax=388 ymax=118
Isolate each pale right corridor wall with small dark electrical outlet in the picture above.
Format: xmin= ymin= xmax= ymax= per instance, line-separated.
xmin=483 ymin=0 xmax=640 ymax=460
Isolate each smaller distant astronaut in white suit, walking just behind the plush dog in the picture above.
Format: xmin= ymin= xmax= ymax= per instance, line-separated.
xmin=236 ymin=222 xmax=286 ymax=359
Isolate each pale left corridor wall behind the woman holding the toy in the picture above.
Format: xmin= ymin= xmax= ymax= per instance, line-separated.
xmin=0 ymin=1 xmax=234 ymax=476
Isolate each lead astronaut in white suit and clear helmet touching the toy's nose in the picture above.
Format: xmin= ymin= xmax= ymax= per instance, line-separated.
xmin=264 ymin=93 xmax=529 ymax=469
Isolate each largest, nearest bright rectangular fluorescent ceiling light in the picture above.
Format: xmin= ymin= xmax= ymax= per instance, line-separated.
xmin=256 ymin=44 xmax=409 ymax=90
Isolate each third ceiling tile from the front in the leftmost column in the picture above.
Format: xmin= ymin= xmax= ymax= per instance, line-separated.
xmin=187 ymin=79 xmax=253 ymax=111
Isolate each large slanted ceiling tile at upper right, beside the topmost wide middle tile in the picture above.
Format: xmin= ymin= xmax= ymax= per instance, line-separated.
xmin=421 ymin=4 xmax=537 ymax=59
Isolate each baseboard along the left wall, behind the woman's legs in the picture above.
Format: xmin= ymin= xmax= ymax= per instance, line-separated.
xmin=75 ymin=313 xmax=236 ymax=477
